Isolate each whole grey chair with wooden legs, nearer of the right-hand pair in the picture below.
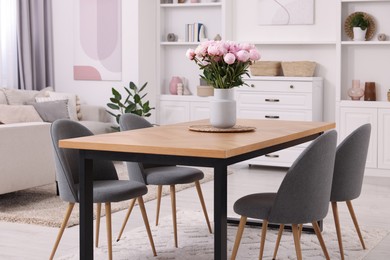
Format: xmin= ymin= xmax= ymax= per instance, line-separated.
xmin=231 ymin=130 xmax=337 ymax=259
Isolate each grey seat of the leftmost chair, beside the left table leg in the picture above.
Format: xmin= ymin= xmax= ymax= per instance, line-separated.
xmin=76 ymin=180 xmax=148 ymax=203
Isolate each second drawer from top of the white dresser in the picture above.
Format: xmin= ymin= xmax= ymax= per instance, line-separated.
xmin=236 ymin=91 xmax=312 ymax=109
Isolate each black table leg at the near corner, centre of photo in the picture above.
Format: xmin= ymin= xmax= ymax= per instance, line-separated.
xmin=214 ymin=165 xmax=227 ymax=260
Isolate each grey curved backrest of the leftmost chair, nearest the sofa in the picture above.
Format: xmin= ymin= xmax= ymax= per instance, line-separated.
xmin=50 ymin=119 xmax=118 ymax=202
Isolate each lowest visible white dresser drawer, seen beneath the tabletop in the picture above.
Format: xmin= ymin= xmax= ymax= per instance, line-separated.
xmin=246 ymin=147 xmax=304 ymax=167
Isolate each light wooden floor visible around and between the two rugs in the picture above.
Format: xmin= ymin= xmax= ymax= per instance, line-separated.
xmin=0 ymin=165 xmax=390 ymax=260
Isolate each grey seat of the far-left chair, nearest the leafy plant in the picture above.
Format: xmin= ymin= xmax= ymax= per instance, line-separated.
xmin=145 ymin=166 xmax=204 ymax=185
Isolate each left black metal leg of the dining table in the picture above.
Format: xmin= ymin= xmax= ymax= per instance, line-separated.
xmin=80 ymin=151 xmax=93 ymax=260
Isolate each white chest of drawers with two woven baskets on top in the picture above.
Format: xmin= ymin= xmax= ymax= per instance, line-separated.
xmin=236 ymin=77 xmax=323 ymax=167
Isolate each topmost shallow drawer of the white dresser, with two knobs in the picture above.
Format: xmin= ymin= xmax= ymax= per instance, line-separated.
xmin=241 ymin=80 xmax=313 ymax=93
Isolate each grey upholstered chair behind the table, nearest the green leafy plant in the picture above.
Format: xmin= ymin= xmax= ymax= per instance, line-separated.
xmin=117 ymin=113 xmax=212 ymax=247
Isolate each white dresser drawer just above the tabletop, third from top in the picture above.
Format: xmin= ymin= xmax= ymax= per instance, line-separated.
xmin=238 ymin=108 xmax=313 ymax=121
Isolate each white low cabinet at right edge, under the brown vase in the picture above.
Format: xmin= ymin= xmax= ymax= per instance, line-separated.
xmin=339 ymin=101 xmax=390 ymax=169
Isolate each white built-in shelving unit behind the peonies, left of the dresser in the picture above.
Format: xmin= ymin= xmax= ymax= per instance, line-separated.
xmin=157 ymin=0 xmax=232 ymax=124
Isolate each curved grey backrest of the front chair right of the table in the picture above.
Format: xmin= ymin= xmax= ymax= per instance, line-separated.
xmin=268 ymin=130 xmax=337 ymax=224
